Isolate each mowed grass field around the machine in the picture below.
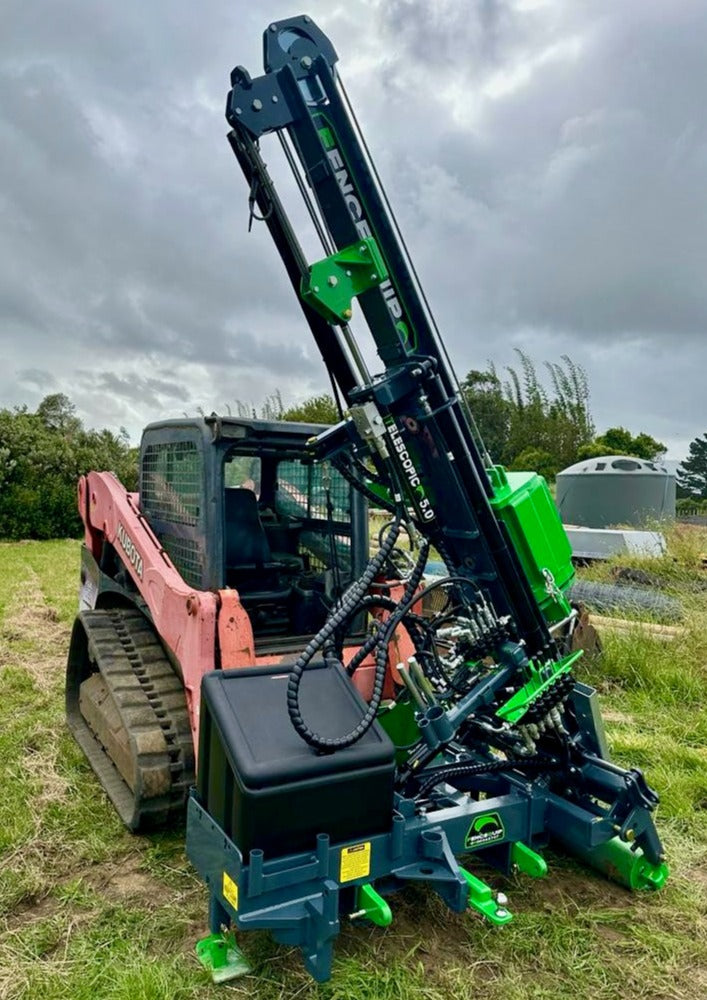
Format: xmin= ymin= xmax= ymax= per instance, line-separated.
xmin=0 ymin=528 xmax=707 ymax=1000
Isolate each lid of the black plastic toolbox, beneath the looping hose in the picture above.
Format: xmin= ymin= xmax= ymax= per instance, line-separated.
xmin=202 ymin=662 xmax=395 ymax=788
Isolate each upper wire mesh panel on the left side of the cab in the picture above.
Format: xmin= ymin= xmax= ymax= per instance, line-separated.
xmin=140 ymin=441 xmax=202 ymax=526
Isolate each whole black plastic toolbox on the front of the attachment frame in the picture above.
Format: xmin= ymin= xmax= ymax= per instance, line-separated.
xmin=197 ymin=663 xmax=395 ymax=861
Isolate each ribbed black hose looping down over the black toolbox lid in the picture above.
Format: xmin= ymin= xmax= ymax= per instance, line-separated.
xmin=287 ymin=511 xmax=404 ymax=753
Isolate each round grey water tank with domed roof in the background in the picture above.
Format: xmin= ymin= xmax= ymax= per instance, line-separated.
xmin=555 ymin=455 xmax=675 ymax=528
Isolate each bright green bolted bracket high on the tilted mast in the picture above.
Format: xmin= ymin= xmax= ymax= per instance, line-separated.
xmin=300 ymin=236 xmax=388 ymax=324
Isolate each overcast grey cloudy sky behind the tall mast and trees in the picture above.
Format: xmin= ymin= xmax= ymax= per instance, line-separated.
xmin=0 ymin=0 xmax=707 ymax=458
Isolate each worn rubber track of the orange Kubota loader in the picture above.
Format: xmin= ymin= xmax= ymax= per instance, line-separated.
xmin=67 ymin=608 xmax=194 ymax=832
